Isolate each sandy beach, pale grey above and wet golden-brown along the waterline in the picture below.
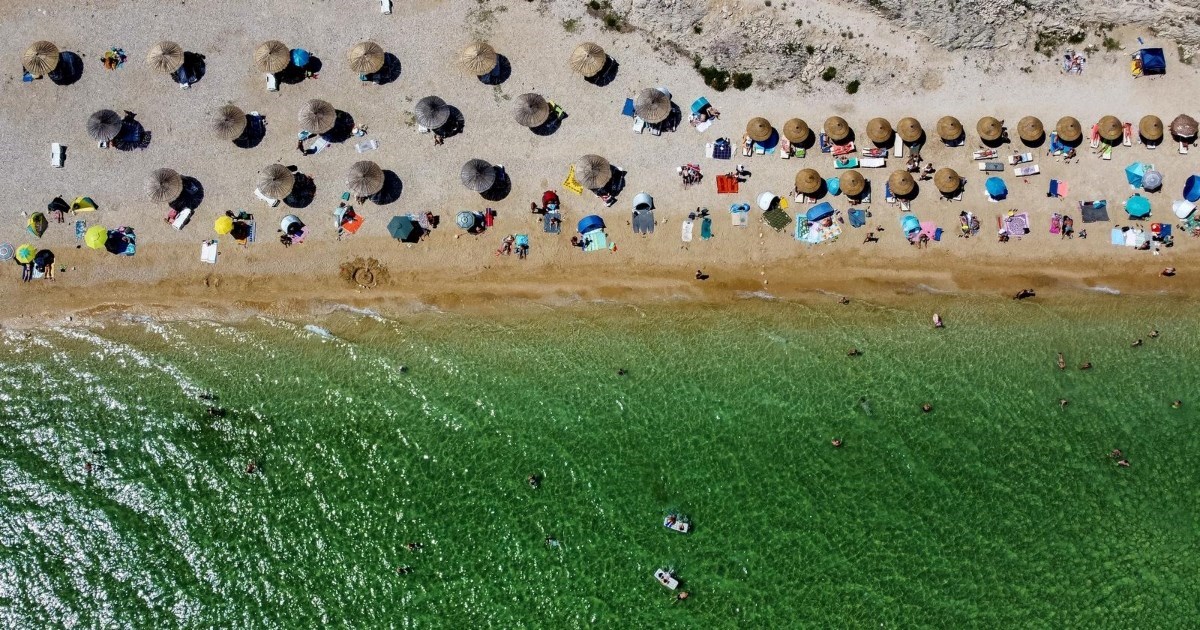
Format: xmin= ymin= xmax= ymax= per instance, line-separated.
xmin=0 ymin=0 xmax=1200 ymax=323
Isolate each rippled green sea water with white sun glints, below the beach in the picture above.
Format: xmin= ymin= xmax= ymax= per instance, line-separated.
xmin=0 ymin=296 xmax=1200 ymax=628
